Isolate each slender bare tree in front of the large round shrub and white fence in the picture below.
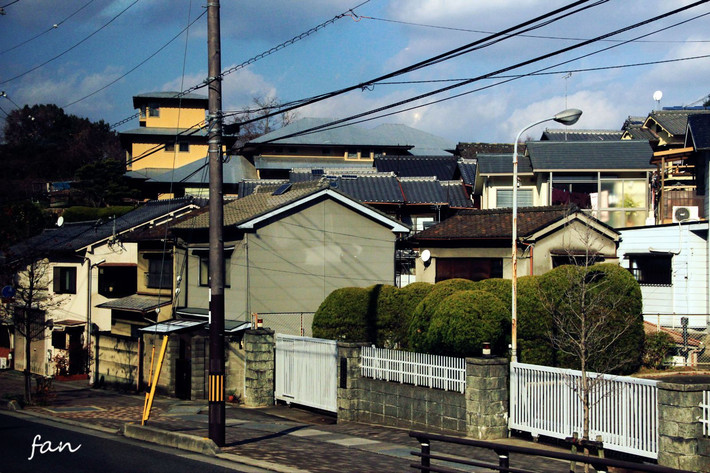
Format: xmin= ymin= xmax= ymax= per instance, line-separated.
xmin=540 ymin=214 xmax=644 ymax=454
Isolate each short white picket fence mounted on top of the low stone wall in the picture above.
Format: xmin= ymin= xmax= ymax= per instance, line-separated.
xmin=360 ymin=347 xmax=466 ymax=393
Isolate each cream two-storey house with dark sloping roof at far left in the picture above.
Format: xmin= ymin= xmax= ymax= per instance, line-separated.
xmin=8 ymin=199 xmax=198 ymax=374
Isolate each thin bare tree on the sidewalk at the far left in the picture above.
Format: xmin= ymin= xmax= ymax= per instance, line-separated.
xmin=0 ymin=257 xmax=61 ymax=403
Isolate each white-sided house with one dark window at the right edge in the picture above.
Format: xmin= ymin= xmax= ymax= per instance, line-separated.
xmin=619 ymin=220 xmax=710 ymax=328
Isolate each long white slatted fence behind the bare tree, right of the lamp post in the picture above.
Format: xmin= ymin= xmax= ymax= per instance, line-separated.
xmin=508 ymin=363 xmax=658 ymax=458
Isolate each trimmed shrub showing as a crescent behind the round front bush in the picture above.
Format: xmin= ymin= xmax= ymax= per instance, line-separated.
xmin=409 ymin=279 xmax=476 ymax=353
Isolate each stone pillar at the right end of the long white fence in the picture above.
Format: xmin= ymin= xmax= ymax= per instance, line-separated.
xmin=658 ymin=376 xmax=710 ymax=472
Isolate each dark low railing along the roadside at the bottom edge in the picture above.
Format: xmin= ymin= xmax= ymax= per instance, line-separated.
xmin=409 ymin=432 xmax=688 ymax=473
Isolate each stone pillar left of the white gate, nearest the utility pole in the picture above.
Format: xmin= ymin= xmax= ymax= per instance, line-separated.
xmin=244 ymin=328 xmax=276 ymax=407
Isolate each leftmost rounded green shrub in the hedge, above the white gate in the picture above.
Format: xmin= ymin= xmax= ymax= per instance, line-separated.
xmin=312 ymin=287 xmax=376 ymax=343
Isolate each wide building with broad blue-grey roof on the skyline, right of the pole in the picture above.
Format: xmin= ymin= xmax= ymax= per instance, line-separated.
xmin=236 ymin=118 xmax=454 ymax=179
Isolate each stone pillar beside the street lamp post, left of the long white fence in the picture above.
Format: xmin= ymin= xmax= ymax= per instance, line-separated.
xmin=466 ymin=358 xmax=510 ymax=440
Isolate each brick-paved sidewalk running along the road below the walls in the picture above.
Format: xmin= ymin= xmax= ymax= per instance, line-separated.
xmin=0 ymin=371 xmax=569 ymax=473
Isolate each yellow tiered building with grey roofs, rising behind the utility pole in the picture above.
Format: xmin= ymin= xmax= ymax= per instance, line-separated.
xmin=120 ymin=92 xmax=234 ymax=175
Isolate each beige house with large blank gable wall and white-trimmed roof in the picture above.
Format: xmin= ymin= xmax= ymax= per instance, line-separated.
xmin=173 ymin=179 xmax=409 ymax=327
